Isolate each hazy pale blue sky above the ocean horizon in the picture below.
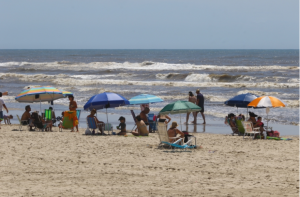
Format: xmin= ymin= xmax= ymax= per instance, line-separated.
xmin=0 ymin=0 xmax=299 ymax=49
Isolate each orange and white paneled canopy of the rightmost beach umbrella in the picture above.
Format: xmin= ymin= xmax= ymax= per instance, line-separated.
xmin=248 ymin=96 xmax=286 ymax=107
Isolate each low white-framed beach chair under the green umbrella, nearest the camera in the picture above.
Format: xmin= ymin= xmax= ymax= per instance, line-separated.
xmin=157 ymin=123 xmax=196 ymax=149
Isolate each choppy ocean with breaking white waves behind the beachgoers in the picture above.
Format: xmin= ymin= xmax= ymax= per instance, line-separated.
xmin=0 ymin=50 xmax=299 ymax=127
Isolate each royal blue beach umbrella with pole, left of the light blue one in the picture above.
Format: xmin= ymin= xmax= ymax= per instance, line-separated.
xmin=83 ymin=92 xmax=129 ymax=122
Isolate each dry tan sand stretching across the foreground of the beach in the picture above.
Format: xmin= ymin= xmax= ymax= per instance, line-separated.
xmin=0 ymin=125 xmax=299 ymax=196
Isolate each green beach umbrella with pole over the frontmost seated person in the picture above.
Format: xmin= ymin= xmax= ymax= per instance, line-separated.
xmin=159 ymin=101 xmax=201 ymax=130
